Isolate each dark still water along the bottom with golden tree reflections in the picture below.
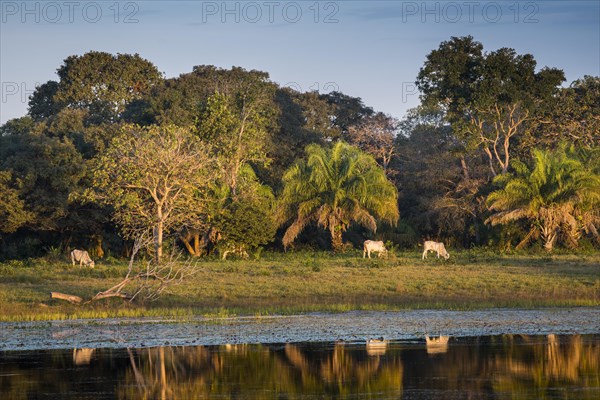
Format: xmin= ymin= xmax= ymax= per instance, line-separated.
xmin=0 ymin=335 xmax=600 ymax=399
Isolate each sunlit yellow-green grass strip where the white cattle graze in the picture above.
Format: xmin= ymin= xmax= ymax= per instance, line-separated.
xmin=0 ymin=250 xmax=600 ymax=321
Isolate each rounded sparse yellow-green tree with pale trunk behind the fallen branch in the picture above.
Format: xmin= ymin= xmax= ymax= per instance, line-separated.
xmin=93 ymin=126 xmax=214 ymax=260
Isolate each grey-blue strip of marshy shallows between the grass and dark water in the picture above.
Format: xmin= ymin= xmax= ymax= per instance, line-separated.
xmin=0 ymin=307 xmax=600 ymax=351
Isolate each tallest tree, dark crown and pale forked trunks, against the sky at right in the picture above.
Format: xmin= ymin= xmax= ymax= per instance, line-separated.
xmin=416 ymin=36 xmax=564 ymax=176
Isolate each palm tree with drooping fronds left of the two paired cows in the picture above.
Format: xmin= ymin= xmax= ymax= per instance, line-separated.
xmin=277 ymin=142 xmax=399 ymax=252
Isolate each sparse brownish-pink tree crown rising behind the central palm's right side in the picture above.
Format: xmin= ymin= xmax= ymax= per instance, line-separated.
xmin=348 ymin=113 xmax=399 ymax=176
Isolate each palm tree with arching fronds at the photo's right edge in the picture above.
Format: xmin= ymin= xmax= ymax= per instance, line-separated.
xmin=486 ymin=145 xmax=600 ymax=251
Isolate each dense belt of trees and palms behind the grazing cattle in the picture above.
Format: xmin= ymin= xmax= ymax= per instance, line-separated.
xmin=0 ymin=50 xmax=600 ymax=258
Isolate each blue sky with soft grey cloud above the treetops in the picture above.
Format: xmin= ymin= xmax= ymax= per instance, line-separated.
xmin=0 ymin=0 xmax=600 ymax=124
